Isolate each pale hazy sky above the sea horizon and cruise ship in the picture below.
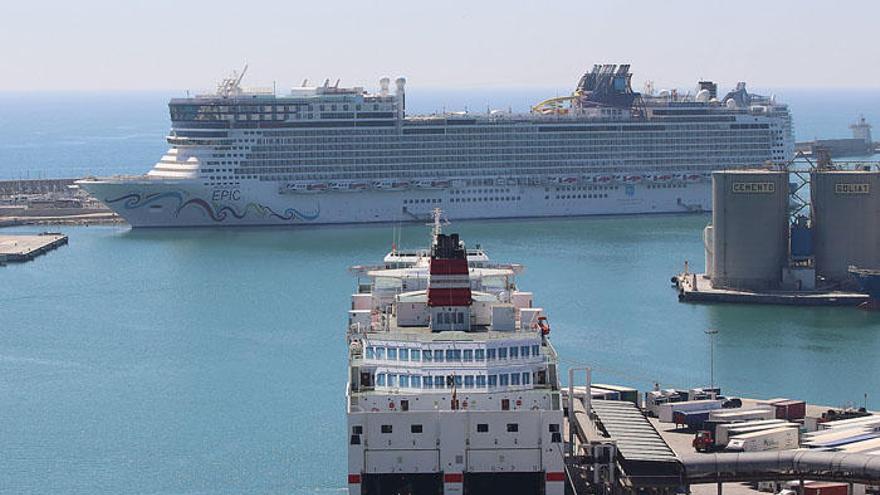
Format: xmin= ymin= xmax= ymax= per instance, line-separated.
xmin=0 ymin=0 xmax=880 ymax=91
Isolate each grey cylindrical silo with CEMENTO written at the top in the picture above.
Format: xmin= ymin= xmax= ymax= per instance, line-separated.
xmin=709 ymin=170 xmax=789 ymax=290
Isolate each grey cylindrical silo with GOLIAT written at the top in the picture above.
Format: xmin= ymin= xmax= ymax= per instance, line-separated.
xmin=810 ymin=170 xmax=880 ymax=288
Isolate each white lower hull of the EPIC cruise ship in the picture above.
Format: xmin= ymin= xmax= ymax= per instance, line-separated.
xmin=78 ymin=179 xmax=711 ymax=227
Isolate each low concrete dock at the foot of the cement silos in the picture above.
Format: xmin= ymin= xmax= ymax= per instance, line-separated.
xmin=673 ymin=273 xmax=870 ymax=306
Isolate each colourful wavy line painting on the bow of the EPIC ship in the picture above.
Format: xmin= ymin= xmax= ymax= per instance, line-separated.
xmin=105 ymin=191 xmax=321 ymax=222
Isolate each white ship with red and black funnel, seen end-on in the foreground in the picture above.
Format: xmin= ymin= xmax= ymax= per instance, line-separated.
xmin=346 ymin=214 xmax=567 ymax=495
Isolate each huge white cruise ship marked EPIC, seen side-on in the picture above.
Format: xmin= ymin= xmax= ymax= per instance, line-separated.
xmin=78 ymin=65 xmax=794 ymax=227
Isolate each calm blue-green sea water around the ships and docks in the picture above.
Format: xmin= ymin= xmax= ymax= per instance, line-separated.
xmin=0 ymin=92 xmax=880 ymax=494
